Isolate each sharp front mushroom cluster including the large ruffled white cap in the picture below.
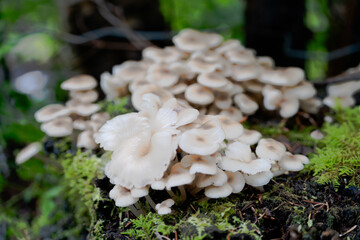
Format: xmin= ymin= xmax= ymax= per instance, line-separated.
xmin=95 ymin=93 xmax=308 ymax=214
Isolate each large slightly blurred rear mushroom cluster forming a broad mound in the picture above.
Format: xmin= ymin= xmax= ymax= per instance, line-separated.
xmin=101 ymin=29 xmax=321 ymax=118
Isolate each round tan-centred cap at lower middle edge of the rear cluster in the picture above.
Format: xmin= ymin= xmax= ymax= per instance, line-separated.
xmin=185 ymin=83 xmax=215 ymax=105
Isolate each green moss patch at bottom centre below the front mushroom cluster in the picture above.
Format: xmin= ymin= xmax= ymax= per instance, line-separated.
xmin=122 ymin=200 xmax=261 ymax=240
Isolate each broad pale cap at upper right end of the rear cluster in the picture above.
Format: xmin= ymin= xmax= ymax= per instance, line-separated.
xmin=260 ymin=67 xmax=305 ymax=86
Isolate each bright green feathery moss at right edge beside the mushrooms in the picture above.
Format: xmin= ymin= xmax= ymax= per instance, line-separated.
xmin=306 ymin=107 xmax=360 ymax=187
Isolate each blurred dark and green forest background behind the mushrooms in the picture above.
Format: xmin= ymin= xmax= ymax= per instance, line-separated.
xmin=0 ymin=0 xmax=360 ymax=236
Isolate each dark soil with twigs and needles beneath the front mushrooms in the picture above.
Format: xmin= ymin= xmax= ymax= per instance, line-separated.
xmin=96 ymin=173 xmax=360 ymax=240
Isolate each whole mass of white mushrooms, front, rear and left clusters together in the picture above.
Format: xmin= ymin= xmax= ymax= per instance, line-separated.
xmin=16 ymin=29 xmax=321 ymax=215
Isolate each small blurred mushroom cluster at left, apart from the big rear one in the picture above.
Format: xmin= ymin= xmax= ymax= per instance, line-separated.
xmin=35 ymin=75 xmax=110 ymax=150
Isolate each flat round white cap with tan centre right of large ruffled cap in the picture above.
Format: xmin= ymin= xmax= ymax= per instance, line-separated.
xmin=179 ymin=120 xmax=225 ymax=155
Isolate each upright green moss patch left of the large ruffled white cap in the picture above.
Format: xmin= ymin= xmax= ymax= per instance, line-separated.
xmin=61 ymin=150 xmax=103 ymax=226
